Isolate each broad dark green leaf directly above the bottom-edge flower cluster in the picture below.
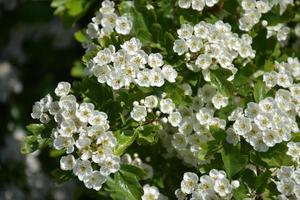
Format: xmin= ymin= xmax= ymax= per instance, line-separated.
xmin=221 ymin=142 xmax=248 ymax=178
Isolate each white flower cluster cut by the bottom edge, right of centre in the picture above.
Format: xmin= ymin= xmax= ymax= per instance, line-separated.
xmin=175 ymin=169 xmax=240 ymax=200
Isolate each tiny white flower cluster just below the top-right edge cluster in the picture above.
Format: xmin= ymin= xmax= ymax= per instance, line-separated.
xmin=267 ymin=24 xmax=290 ymax=42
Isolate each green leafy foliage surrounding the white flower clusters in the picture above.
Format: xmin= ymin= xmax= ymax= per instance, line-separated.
xmin=21 ymin=0 xmax=300 ymax=200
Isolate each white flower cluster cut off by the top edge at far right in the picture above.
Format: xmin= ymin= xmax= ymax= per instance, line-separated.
xmin=239 ymin=0 xmax=293 ymax=31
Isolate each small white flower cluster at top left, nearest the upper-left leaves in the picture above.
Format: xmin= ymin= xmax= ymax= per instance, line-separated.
xmin=86 ymin=0 xmax=133 ymax=39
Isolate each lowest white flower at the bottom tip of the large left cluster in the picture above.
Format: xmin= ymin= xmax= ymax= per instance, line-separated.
xmin=83 ymin=171 xmax=106 ymax=191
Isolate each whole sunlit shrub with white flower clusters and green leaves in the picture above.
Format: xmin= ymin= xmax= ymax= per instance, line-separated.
xmin=22 ymin=0 xmax=300 ymax=200
